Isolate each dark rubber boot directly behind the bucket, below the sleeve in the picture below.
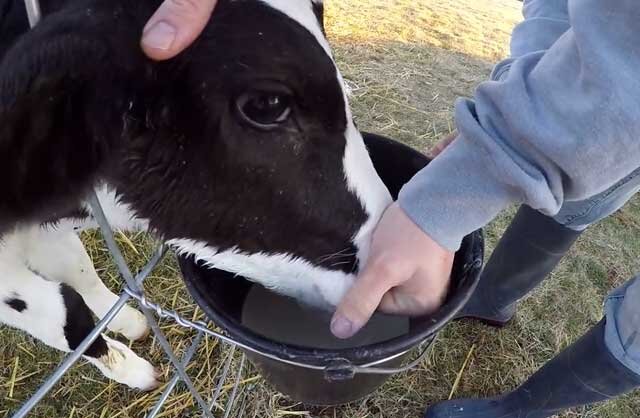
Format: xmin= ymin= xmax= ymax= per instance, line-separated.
xmin=456 ymin=206 xmax=580 ymax=327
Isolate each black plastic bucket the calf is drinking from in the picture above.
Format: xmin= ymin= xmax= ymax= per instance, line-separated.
xmin=179 ymin=134 xmax=484 ymax=406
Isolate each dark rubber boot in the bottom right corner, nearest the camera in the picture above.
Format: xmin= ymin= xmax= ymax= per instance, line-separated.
xmin=425 ymin=321 xmax=640 ymax=418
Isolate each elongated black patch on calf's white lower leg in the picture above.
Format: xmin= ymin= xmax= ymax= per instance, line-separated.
xmin=60 ymin=284 xmax=109 ymax=358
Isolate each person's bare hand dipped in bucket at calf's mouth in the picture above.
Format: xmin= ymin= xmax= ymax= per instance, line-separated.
xmin=331 ymin=204 xmax=455 ymax=339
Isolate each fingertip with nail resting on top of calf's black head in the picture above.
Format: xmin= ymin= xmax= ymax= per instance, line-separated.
xmin=141 ymin=0 xmax=218 ymax=61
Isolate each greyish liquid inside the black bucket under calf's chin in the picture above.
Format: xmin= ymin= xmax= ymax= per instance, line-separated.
xmin=242 ymin=285 xmax=409 ymax=350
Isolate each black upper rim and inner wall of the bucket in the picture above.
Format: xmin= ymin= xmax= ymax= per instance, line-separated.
xmin=178 ymin=133 xmax=484 ymax=367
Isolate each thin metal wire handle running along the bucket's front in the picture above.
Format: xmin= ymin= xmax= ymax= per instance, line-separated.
xmin=124 ymin=286 xmax=436 ymax=381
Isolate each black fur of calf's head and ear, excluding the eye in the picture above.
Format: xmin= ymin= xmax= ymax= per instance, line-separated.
xmin=0 ymin=0 xmax=367 ymax=272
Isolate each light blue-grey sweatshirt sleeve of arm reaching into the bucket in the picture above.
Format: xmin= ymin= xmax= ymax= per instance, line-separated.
xmin=399 ymin=0 xmax=640 ymax=250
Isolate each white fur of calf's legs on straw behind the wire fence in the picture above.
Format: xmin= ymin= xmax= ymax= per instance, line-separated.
xmin=0 ymin=225 xmax=158 ymax=390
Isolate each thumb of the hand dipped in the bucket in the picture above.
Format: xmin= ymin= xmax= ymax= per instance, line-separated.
xmin=331 ymin=266 xmax=392 ymax=339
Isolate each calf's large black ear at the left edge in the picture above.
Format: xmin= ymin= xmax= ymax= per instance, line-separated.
xmin=0 ymin=0 xmax=153 ymax=233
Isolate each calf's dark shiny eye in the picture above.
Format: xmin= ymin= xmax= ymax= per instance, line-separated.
xmin=236 ymin=92 xmax=291 ymax=129
